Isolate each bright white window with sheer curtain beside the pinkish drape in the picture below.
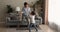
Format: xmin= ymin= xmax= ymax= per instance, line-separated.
xmin=48 ymin=0 xmax=60 ymax=30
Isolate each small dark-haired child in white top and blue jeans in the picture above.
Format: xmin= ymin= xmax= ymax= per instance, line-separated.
xmin=29 ymin=11 xmax=38 ymax=32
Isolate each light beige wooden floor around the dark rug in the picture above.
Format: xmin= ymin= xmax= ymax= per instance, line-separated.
xmin=0 ymin=25 xmax=56 ymax=32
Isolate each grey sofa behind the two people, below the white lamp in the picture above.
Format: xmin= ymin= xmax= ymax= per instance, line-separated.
xmin=6 ymin=13 xmax=42 ymax=26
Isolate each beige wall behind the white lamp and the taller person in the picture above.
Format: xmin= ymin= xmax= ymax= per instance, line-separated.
xmin=0 ymin=0 xmax=37 ymax=22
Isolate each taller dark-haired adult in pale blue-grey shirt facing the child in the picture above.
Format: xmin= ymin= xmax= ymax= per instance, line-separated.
xmin=22 ymin=2 xmax=31 ymax=21
